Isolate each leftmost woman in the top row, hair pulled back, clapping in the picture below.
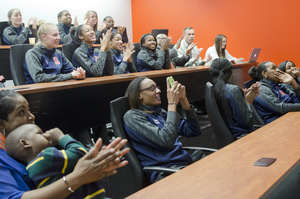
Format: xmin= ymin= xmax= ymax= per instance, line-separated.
xmin=2 ymin=8 xmax=37 ymax=45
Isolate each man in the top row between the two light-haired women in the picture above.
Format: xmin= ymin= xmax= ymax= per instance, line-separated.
xmin=57 ymin=10 xmax=78 ymax=44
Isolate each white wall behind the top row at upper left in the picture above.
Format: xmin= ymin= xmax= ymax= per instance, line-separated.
xmin=0 ymin=0 xmax=132 ymax=41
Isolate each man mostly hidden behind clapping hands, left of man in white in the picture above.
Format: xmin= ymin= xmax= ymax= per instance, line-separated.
xmin=156 ymin=33 xmax=192 ymax=67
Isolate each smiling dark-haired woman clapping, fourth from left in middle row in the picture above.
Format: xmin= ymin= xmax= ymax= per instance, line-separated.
xmin=136 ymin=33 xmax=171 ymax=72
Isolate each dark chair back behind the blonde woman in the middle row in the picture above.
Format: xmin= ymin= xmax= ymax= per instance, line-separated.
xmin=10 ymin=44 xmax=34 ymax=86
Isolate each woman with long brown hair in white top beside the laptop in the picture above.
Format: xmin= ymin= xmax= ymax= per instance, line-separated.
xmin=205 ymin=34 xmax=244 ymax=65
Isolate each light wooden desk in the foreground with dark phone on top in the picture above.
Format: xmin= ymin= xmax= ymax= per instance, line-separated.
xmin=128 ymin=112 xmax=300 ymax=199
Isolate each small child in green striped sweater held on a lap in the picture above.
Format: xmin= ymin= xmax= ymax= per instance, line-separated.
xmin=6 ymin=124 xmax=111 ymax=198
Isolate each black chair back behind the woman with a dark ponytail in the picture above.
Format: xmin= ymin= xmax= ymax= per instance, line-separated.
xmin=205 ymin=82 xmax=234 ymax=148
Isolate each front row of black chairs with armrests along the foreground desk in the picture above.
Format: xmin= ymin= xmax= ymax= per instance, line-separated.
xmin=110 ymin=80 xmax=264 ymax=196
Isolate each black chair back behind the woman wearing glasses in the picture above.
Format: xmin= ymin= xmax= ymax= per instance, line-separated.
xmin=110 ymin=97 xmax=150 ymax=191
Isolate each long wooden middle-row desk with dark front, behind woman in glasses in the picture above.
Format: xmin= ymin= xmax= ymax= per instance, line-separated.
xmin=1 ymin=63 xmax=257 ymax=133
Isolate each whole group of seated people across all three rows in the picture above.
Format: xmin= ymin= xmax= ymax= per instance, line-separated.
xmin=0 ymin=7 xmax=300 ymax=198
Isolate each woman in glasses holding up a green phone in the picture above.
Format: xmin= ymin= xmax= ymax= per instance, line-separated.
xmin=123 ymin=77 xmax=202 ymax=183
